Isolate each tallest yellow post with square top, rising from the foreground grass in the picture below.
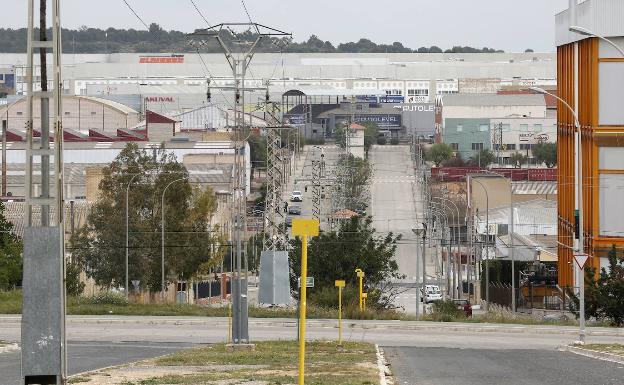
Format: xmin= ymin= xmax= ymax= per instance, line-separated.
xmin=292 ymin=219 xmax=319 ymax=385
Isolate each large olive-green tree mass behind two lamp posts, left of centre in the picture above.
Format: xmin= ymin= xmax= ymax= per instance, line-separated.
xmin=69 ymin=143 xmax=219 ymax=290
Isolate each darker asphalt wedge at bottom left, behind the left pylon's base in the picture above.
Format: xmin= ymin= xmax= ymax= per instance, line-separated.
xmin=0 ymin=341 xmax=196 ymax=385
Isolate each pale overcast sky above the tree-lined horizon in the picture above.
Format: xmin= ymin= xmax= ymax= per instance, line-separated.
xmin=2 ymin=0 xmax=568 ymax=52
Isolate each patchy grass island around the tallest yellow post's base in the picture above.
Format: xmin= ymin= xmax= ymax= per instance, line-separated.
xmin=146 ymin=341 xmax=378 ymax=385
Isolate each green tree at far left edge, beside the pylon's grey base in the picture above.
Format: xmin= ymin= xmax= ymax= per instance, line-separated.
xmin=0 ymin=201 xmax=23 ymax=290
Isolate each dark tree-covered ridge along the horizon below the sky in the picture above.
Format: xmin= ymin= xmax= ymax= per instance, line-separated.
xmin=0 ymin=23 xmax=504 ymax=53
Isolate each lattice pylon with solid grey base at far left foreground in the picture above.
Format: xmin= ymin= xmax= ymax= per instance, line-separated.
xmin=21 ymin=0 xmax=67 ymax=385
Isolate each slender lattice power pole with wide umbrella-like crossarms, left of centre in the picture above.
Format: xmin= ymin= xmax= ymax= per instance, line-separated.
xmin=189 ymin=22 xmax=291 ymax=344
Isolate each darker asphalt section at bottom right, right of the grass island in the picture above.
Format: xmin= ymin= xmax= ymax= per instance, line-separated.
xmin=384 ymin=347 xmax=624 ymax=385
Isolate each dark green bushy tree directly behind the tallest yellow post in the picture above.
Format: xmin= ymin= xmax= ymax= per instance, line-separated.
xmin=289 ymin=217 xmax=402 ymax=308
